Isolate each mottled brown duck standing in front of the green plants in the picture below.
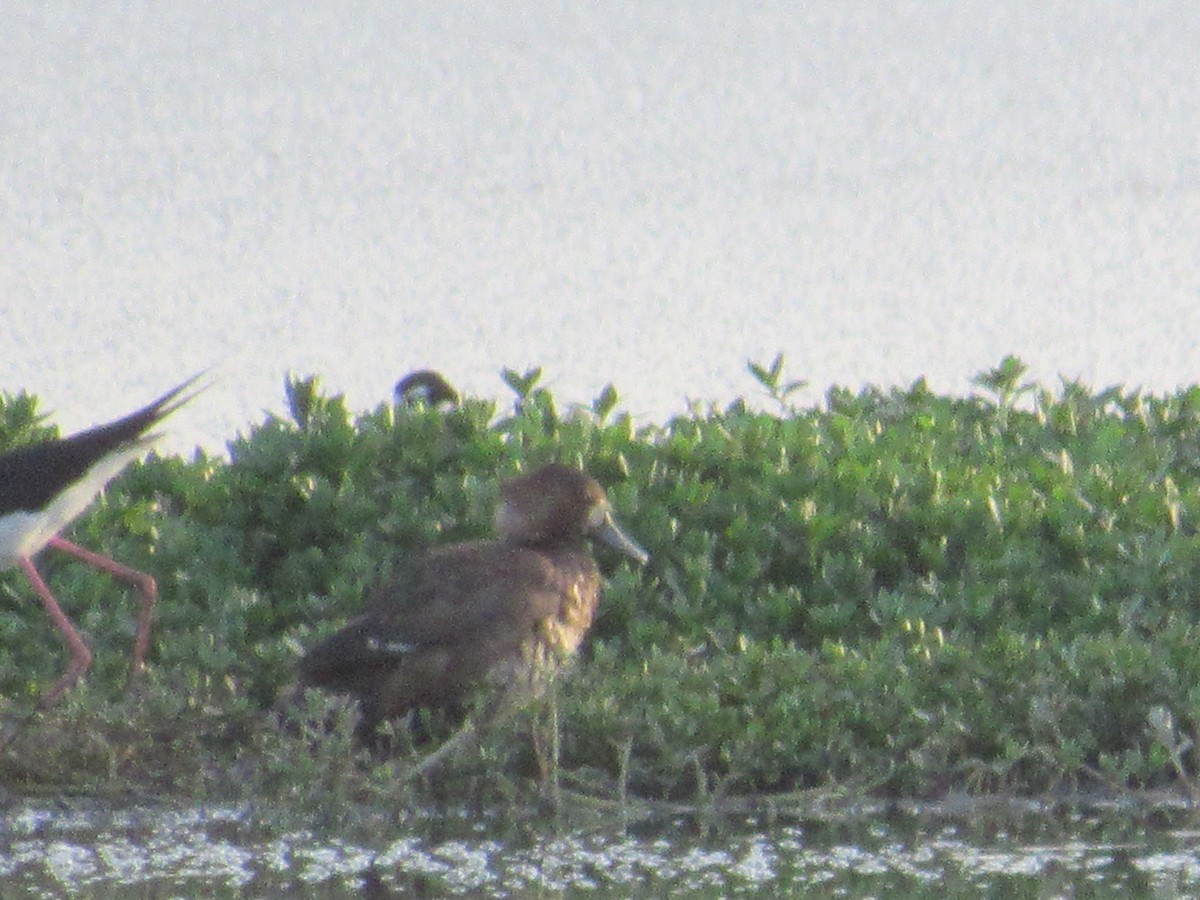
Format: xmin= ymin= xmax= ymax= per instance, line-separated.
xmin=299 ymin=464 xmax=649 ymax=742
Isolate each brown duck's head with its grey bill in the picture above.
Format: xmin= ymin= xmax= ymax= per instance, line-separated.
xmin=496 ymin=463 xmax=650 ymax=563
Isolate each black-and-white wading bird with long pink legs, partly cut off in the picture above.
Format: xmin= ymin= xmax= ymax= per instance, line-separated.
xmin=0 ymin=376 xmax=199 ymax=708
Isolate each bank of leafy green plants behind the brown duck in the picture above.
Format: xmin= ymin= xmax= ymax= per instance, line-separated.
xmin=7 ymin=359 xmax=1200 ymax=806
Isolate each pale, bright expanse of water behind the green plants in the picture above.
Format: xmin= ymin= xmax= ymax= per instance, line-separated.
xmin=0 ymin=0 xmax=1200 ymax=449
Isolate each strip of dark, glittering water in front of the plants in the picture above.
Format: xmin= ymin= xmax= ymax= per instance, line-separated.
xmin=0 ymin=804 xmax=1200 ymax=898
